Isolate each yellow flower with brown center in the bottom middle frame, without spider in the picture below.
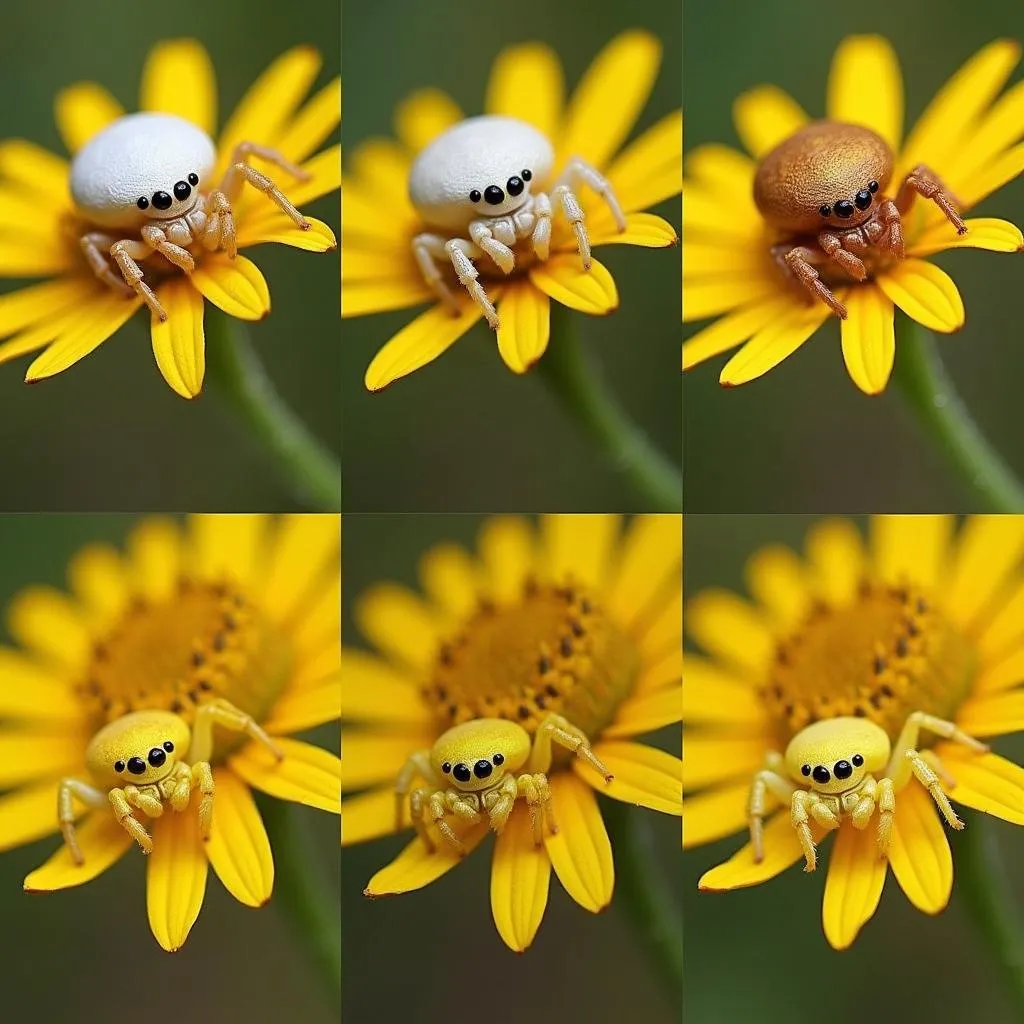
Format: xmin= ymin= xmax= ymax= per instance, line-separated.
xmin=342 ymin=515 xmax=682 ymax=950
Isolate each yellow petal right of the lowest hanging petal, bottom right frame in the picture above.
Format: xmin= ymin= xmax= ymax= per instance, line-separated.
xmin=888 ymin=784 xmax=953 ymax=913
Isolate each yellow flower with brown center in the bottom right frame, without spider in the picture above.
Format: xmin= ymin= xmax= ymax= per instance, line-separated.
xmin=683 ymin=516 xmax=1024 ymax=949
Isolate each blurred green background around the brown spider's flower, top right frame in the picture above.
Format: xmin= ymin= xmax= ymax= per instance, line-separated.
xmin=684 ymin=0 xmax=1024 ymax=513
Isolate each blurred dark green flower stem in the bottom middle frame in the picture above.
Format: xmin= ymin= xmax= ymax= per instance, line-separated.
xmin=603 ymin=800 xmax=683 ymax=1000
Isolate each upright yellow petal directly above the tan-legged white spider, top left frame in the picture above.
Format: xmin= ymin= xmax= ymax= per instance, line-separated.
xmin=138 ymin=39 xmax=217 ymax=135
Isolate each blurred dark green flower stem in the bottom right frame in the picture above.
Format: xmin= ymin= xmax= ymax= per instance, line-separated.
xmin=956 ymin=815 xmax=1024 ymax=1021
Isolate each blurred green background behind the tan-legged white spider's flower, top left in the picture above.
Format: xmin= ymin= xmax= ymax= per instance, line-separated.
xmin=0 ymin=0 xmax=341 ymax=511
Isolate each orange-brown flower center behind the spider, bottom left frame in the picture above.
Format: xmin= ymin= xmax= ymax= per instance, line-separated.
xmin=76 ymin=578 xmax=291 ymax=756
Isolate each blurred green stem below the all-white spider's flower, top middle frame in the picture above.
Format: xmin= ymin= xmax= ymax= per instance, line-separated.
xmin=538 ymin=302 xmax=683 ymax=512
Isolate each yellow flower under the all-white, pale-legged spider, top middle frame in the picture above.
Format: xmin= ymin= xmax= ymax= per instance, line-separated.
xmin=342 ymin=32 xmax=682 ymax=391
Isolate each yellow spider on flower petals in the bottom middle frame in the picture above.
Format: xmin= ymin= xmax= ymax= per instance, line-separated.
xmin=394 ymin=715 xmax=612 ymax=854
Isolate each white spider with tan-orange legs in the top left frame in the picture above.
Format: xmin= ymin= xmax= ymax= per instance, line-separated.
xmin=71 ymin=113 xmax=309 ymax=321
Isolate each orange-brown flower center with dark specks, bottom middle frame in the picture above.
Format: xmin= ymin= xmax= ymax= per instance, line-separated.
xmin=422 ymin=581 xmax=640 ymax=761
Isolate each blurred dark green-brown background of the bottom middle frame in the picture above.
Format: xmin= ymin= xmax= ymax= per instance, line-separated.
xmin=341 ymin=515 xmax=681 ymax=1024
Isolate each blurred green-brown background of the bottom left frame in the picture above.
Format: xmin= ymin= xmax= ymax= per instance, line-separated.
xmin=0 ymin=515 xmax=338 ymax=1024
